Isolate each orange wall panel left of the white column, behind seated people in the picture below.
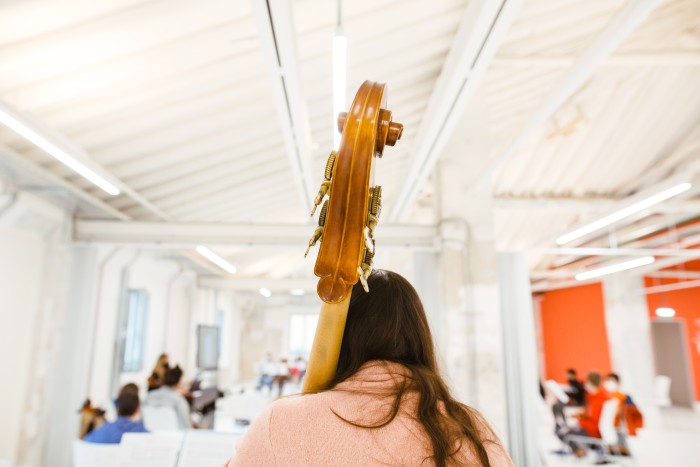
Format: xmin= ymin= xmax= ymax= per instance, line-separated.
xmin=540 ymin=283 xmax=610 ymax=381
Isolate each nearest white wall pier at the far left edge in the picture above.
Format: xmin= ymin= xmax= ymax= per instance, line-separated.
xmin=0 ymin=193 xmax=71 ymax=465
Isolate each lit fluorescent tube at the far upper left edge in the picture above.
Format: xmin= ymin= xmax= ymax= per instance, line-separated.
xmin=0 ymin=106 xmax=119 ymax=196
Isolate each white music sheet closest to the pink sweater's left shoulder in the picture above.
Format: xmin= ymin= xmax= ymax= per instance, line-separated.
xmin=177 ymin=431 xmax=240 ymax=467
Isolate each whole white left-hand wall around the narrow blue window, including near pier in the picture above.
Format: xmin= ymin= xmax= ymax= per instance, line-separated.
xmin=0 ymin=186 xmax=213 ymax=467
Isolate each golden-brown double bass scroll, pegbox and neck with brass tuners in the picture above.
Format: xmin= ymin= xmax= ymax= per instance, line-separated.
xmin=303 ymin=81 xmax=403 ymax=393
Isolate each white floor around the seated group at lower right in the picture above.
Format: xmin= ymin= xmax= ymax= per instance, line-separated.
xmin=539 ymin=407 xmax=700 ymax=467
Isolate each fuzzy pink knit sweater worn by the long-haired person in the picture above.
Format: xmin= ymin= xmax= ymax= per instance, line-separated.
xmin=228 ymin=362 xmax=513 ymax=467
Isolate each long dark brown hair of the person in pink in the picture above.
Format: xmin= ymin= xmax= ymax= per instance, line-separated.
xmin=327 ymin=270 xmax=497 ymax=467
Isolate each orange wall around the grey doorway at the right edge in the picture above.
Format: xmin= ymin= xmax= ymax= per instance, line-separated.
xmin=644 ymin=277 xmax=700 ymax=400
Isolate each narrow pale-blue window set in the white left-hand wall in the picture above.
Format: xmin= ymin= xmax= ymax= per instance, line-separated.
xmin=121 ymin=289 xmax=148 ymax=372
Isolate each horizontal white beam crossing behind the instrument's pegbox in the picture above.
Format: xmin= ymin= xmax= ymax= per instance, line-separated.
xmin=73 ymin=220 xmax=439 ymax=248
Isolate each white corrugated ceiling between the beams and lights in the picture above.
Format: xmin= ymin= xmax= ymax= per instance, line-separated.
xmin=0 ymin=0 xmax=700 ymax=290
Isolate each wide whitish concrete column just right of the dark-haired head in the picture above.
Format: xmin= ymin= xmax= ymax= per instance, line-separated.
xmin=435 ymin=99 xmax=506 ymax=441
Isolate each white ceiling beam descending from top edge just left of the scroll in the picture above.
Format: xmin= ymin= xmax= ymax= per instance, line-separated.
xmin=251 ymin=0 xmax=314 ymax=212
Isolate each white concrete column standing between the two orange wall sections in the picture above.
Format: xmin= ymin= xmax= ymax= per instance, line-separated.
xmin=603 ymin=272 xmax=654 ymax=400
